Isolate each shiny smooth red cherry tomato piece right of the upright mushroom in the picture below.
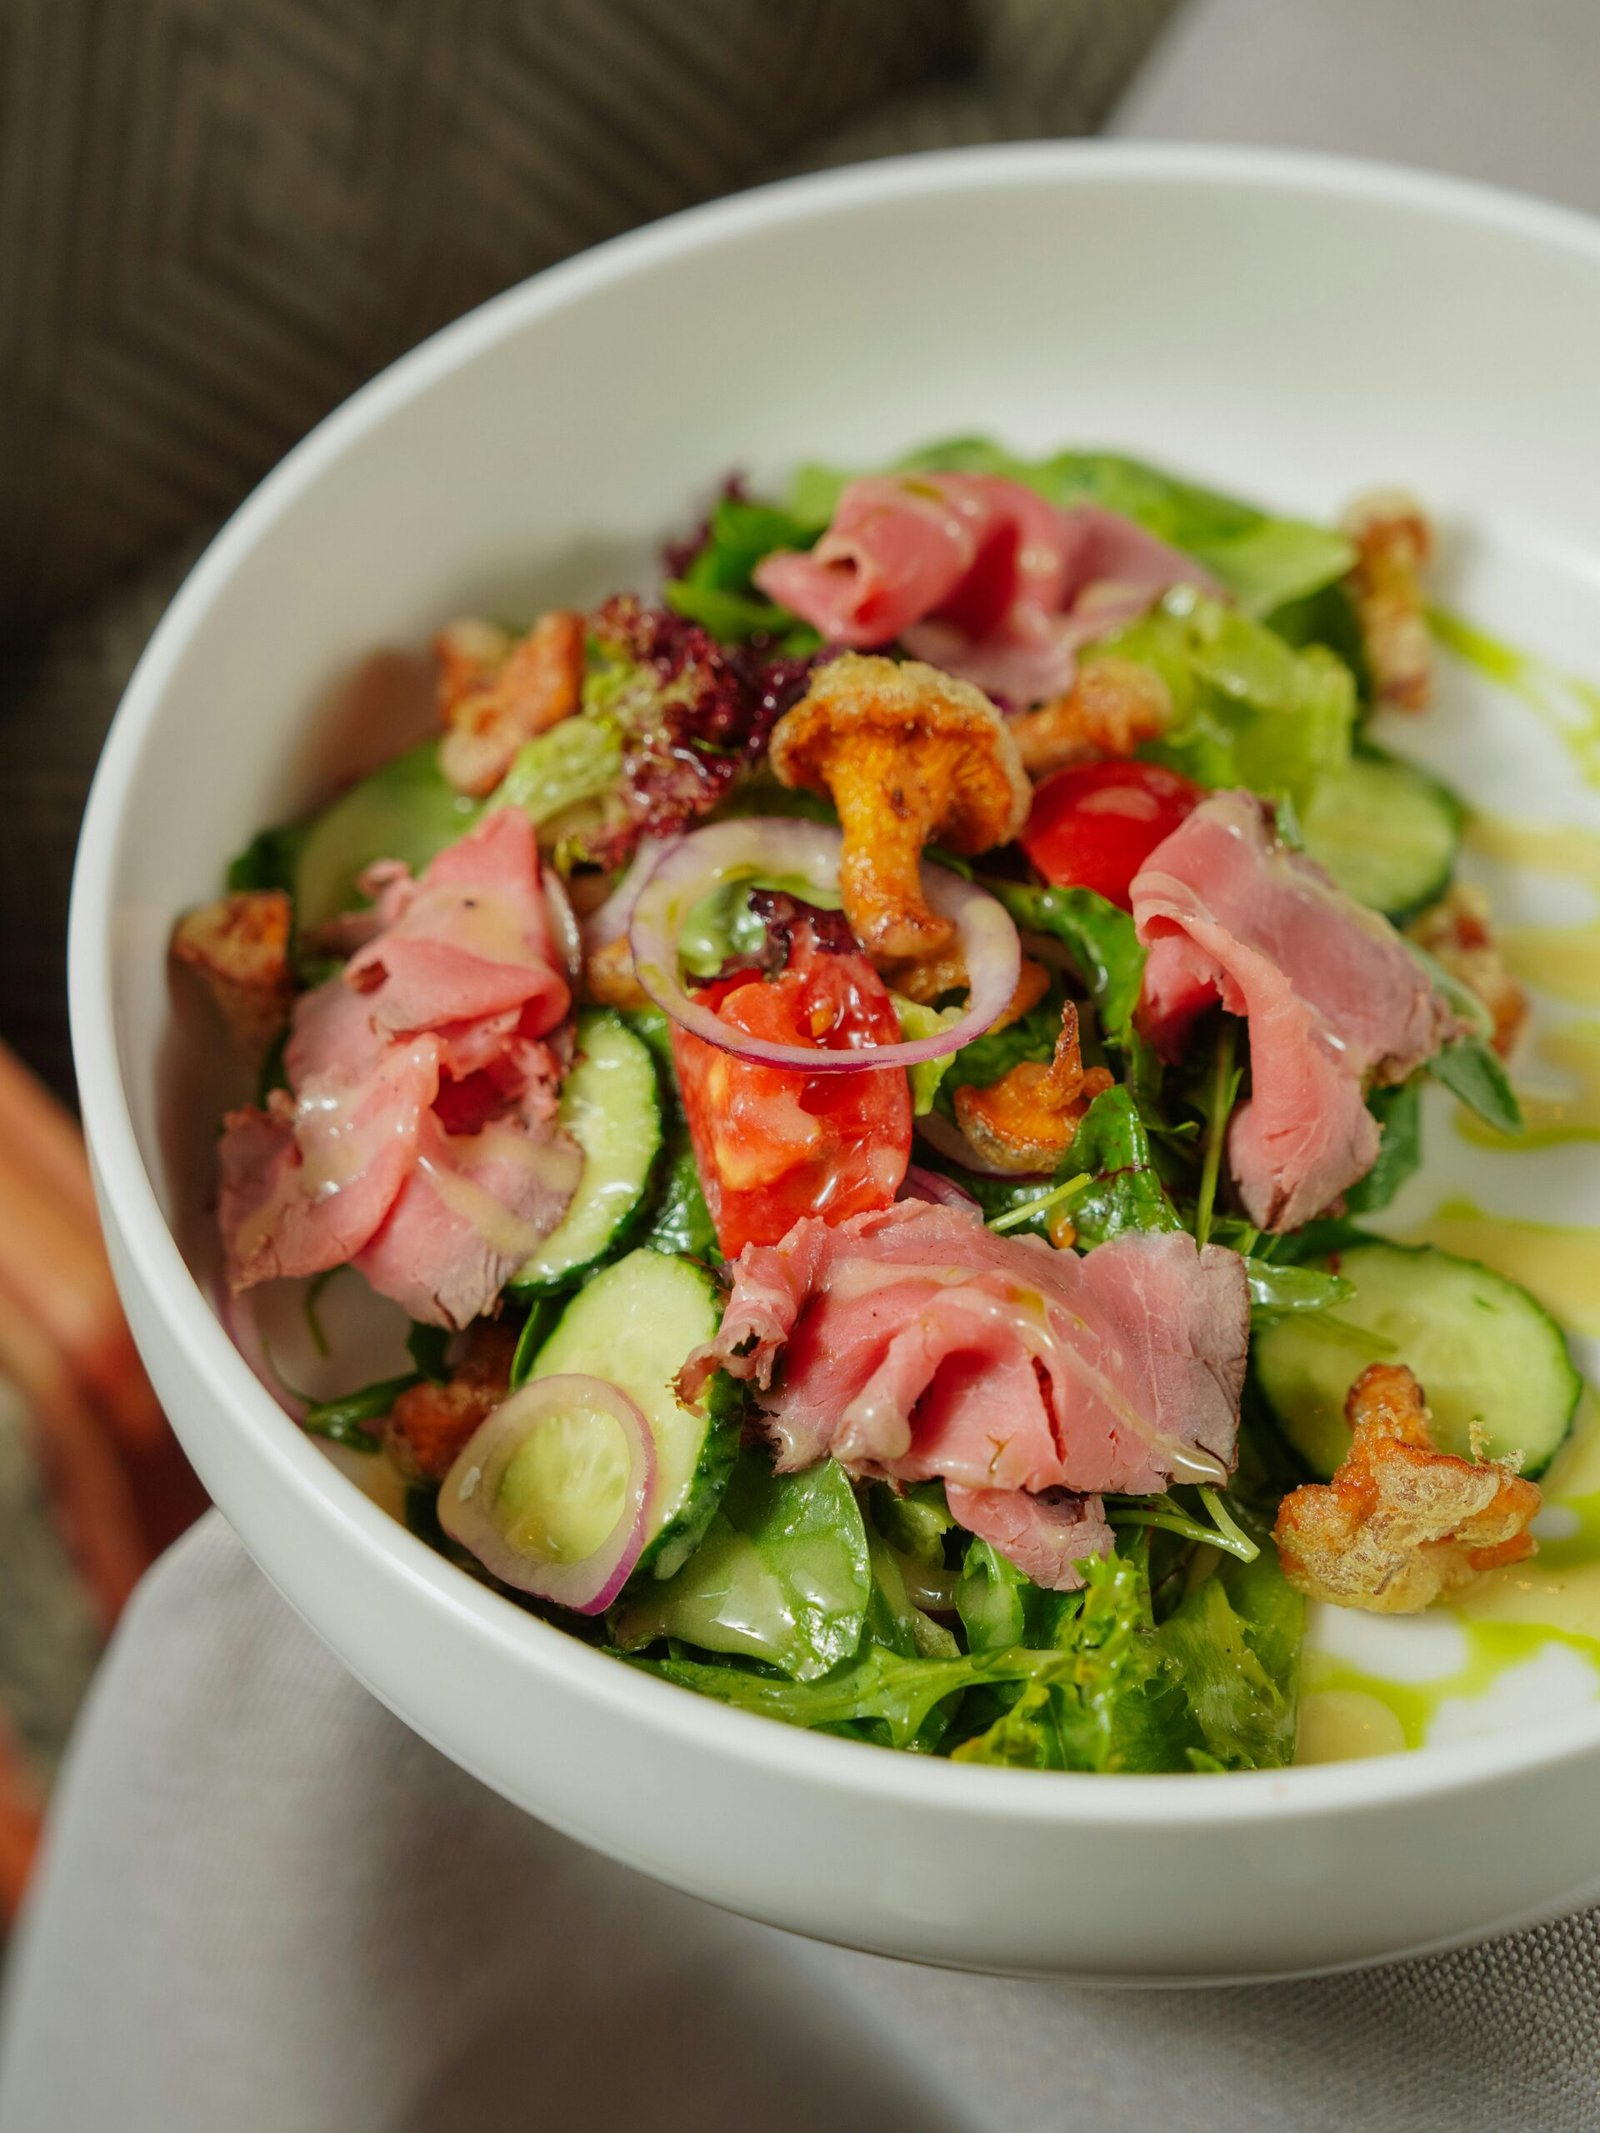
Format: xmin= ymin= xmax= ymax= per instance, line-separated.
xmin=1020 ymin=761 xmax=1205 ymax=911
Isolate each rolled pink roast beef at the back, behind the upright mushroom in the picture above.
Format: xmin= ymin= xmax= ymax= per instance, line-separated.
xmin=755 ymin=474 xmax=1216 ymax=704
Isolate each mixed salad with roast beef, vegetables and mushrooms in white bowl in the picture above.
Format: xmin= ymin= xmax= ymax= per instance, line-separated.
xmin=173 ymin=439 xmax=1581 ymax=1773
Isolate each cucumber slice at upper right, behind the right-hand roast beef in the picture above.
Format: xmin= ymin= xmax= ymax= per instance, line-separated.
xmin=1299 ymin=749 xmax=1461 ymax=921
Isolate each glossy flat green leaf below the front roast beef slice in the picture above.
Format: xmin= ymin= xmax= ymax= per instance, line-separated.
xmin=610 ymin=1446 xmax=866 ymax=1681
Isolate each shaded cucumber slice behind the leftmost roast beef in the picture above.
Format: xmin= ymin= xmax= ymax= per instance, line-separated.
xmin=290 ymin=740 xmax=482 ymax=932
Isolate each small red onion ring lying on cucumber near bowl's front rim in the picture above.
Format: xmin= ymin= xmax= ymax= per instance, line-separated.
xmin=439 ymin=1372 xmax=655 ymax=1615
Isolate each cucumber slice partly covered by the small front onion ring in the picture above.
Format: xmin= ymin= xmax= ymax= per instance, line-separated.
xmin=529 ymin=1250 xmax=742 ymax=1578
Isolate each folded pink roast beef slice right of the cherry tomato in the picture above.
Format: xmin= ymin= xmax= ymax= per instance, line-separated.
xmin=1131 ymin=791 xmax=1457 ymax=1231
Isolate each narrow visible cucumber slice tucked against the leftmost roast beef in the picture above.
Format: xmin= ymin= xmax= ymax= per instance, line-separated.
xmin=506 ymin=1009 xmax=661 ymax=1297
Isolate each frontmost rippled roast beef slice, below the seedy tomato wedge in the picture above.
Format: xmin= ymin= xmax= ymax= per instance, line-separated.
xmin=678 ymin=1201 xmax=1248 ymax=1493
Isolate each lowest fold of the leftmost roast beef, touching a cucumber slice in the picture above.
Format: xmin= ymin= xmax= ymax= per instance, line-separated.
xmin=354 ymin=1111 xmax=582 ymax=1329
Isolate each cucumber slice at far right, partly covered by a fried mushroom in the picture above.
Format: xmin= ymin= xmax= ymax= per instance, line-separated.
xmin=1254 ymin=1244 xmax=1583 ymax=1480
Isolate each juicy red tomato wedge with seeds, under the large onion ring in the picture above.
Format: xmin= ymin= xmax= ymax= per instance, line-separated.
xmin=672 ymin=928 xmax=911 ymax=1258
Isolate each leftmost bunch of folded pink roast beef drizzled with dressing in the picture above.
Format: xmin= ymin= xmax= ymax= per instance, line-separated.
xmin=220 ymin=808 xmax=580 ymax=1327
